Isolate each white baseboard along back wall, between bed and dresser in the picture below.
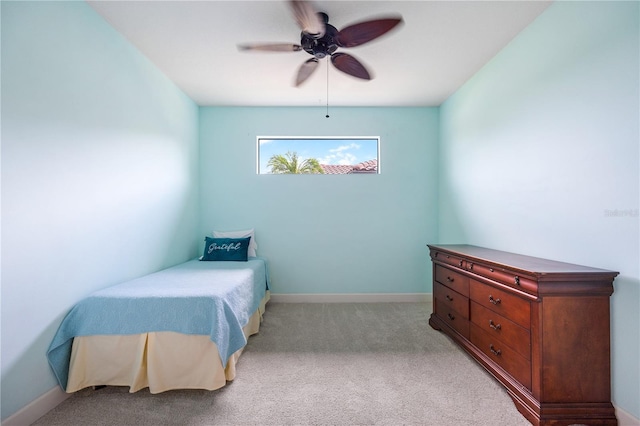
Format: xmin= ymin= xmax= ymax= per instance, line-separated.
xmin=270 ymin=293 xmax=432 ymax=303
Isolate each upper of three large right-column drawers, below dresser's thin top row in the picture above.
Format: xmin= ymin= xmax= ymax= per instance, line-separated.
xmin=469 ymin=280 xmax=531 ymax=330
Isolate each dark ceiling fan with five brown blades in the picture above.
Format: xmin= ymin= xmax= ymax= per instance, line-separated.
xmin=238 ymin=0 xmax=402 ymax=86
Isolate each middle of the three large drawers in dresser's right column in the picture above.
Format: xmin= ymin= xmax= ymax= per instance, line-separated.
xmin=471 ymin=302 xmax=531 ymax=360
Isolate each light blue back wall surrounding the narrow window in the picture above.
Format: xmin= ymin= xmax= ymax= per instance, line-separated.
xmin=200 ymin=107 xmax=439 ymax=293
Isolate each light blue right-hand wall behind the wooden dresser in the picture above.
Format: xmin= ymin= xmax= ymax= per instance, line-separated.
xmin=439 ymin=2 xmax=640 ymax=417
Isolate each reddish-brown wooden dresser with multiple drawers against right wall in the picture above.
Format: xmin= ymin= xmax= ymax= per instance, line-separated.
xmin=428 ymin=245 xmax=618 ymax=425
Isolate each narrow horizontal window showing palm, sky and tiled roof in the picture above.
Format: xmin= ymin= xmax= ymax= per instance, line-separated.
xmin=257 ymin=136 xmax=380 ymax=175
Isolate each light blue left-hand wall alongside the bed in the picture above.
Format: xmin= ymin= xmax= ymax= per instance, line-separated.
xmin=2 ymin=1 xmax=198 ymax=419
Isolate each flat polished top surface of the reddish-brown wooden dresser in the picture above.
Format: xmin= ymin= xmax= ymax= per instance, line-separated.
xmin=427 ymin=244 xmax=618 ymax=278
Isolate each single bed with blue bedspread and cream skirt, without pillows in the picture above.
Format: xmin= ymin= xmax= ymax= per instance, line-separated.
xmin=47 ymin=253 xmax=269 ymax=393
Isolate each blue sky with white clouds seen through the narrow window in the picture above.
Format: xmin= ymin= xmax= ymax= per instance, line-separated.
xmin=258 ymin=137 xmax=378 ymax=174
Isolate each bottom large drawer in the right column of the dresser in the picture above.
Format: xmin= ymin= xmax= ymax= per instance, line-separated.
xmin=469 ymin=323 xmax=531 ymax=390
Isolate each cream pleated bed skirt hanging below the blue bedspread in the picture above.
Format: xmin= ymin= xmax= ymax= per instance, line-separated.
xmin=66 ymin=292 xmax=269 ymax=393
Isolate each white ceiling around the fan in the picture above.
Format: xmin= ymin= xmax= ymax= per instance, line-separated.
xmin=88 ymin=0 xmax=550 ymax=106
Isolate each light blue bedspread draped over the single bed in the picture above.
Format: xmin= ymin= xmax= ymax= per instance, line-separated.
xmin=47 ymin=258 xmax=269 ymax=389
